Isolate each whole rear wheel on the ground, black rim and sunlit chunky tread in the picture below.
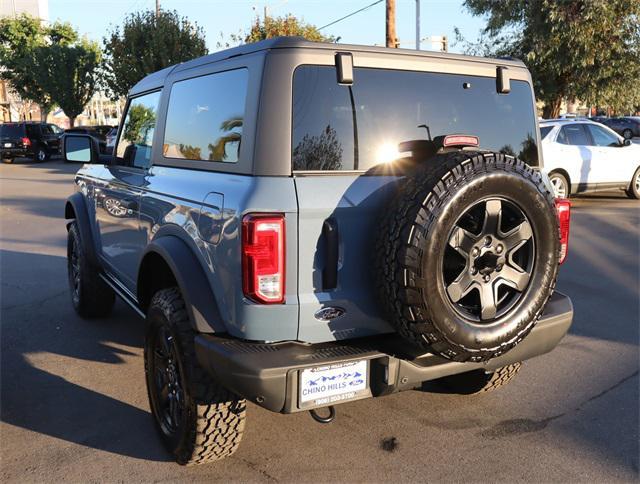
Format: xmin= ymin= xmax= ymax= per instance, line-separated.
xmin=144 ymin=287 xmax=246 ymax=465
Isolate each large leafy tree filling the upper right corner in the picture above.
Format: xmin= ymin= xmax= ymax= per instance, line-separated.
xmin=465 ymin=0 xmax=640 ymax=117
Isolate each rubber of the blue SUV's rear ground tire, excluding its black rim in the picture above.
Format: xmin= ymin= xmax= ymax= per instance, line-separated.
xmin=144 ymin=287 xmax=246 ymax=465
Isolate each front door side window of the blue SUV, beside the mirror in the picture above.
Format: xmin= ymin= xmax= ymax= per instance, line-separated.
xmin=115 ymin=91 xmax=160 ymax=168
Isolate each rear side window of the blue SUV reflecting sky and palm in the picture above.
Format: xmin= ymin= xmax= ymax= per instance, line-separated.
xmin=162 ymin=69 xmax=249 ymax=163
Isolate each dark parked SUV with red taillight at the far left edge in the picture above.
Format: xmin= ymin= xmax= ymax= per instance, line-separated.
xmin=0 ymin=121 xmax=62 ymax=163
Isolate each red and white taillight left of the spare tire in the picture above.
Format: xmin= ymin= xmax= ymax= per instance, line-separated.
xmin=242 ymin=214 xmax=285 ymax=304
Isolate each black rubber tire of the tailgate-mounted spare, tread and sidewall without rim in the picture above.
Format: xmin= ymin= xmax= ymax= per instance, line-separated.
xmin=375 ymin=151 xmax=560 ymax=361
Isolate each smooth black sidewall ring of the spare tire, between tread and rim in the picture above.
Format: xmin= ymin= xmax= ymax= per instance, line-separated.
xmin=401 ymin=161 xmax=559 ymax=359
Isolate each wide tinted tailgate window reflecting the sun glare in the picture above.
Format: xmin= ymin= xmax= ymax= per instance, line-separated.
xmin=292 ymin=66 xmax=538 ymax=170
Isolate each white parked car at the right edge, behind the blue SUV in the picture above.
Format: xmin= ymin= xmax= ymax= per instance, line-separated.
xmin=540 ymin=119 xmax=640 ymax=199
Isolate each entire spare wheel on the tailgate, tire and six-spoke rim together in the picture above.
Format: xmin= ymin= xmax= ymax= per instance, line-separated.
xmin=376 ymin=151 xmax=560 ymax=361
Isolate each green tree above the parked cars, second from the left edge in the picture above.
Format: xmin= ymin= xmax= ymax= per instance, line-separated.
xmin=34 ymin=39 xmax=101 ymax=127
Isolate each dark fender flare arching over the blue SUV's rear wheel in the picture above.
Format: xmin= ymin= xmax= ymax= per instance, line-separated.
xmin=137 ymin=235 xmax=226 ymax=333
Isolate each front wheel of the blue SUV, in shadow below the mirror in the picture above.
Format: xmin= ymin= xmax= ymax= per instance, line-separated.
xmin=67 ymin=221 xmax=115 ymax=318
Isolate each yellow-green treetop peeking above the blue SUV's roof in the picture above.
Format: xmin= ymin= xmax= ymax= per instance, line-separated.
xmin=218 ymin=14 xmax=336 ymax=48
